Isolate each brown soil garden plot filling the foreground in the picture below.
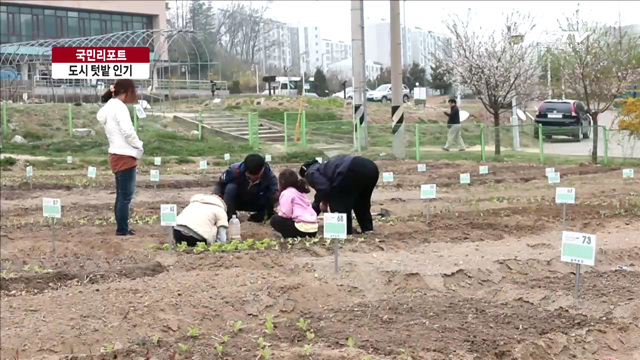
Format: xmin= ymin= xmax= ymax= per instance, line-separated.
xmin=0 ymin=161 xmax=640 ymax=360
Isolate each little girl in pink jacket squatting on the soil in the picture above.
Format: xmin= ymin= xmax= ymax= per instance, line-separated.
xmin=271 ymin=169 xmax=318 ymax=239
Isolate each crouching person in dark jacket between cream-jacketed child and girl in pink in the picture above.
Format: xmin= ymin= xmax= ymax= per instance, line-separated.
xmin=213 ymin=154 xmax=278 ymax=222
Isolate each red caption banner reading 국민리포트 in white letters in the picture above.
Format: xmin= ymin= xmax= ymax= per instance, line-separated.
xmin=51 ymin=47 xmax=150 ymax=64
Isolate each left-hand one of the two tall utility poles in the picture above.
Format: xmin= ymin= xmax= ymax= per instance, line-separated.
xmin=352 ymin=0 xmax=367 ymax=149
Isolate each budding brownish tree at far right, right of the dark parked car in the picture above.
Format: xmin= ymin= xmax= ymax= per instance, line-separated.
xmin=559 ymin=13 xmax=640 ymax=163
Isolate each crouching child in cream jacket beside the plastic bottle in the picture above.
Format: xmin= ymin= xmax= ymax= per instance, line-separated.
xmin=173 ymin=194 xmax=229 ymax=247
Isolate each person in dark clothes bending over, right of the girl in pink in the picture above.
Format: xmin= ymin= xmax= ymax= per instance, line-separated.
xmin=300 ymin=155 xmax=380 ymax=235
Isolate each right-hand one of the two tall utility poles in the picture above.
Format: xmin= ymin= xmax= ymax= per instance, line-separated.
xmin=389 ymin=0 xmax=405 ymax=159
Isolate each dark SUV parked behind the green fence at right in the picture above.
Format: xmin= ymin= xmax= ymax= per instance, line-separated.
xmin=534 ymin=100 xmax=592 ymax=141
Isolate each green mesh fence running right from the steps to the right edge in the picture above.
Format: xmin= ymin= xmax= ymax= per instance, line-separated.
xmin=241 ymin=112 xmax=640 ymax=164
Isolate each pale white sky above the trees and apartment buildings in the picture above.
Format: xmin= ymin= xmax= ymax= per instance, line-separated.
xmin=246 ymin=0 xmax=640 ymax=42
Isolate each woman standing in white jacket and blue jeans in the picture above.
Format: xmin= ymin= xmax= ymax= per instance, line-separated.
xmin=97 ymin=79 xmax=144 ymax=236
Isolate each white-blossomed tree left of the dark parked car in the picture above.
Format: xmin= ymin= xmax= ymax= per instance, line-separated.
xmin=445 ymin=12 xmax=538 ymax=155
